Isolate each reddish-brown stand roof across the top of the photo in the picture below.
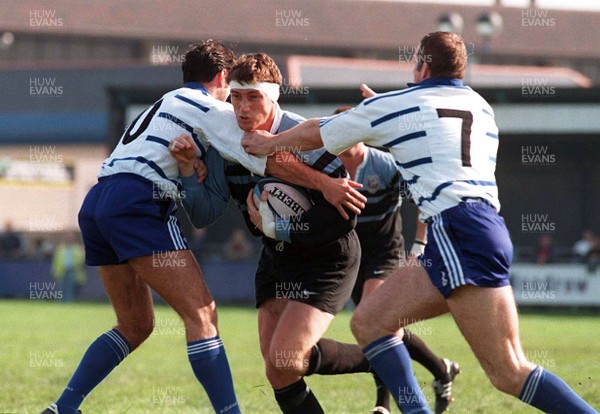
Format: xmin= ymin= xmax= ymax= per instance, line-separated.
xmin=0 ymin=0 xmax=600 ymax=59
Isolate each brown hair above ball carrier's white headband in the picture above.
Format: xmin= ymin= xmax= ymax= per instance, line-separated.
xmin=227 ymin=53 xmax=283 ymax=85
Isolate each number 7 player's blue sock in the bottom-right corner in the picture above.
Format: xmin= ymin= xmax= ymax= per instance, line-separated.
xmin=519 ymin=366 xmax=597 ymax=414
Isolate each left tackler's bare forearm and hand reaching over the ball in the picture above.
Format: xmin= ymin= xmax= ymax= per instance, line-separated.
xmin=266 ymin=152 xmax=367 ymax=220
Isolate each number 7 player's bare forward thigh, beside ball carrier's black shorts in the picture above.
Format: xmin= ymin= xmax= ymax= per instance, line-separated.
xmin=352 ymin=262 xmax=448 ymax=346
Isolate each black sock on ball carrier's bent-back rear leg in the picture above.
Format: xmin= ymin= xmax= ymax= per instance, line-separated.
xmin=306 ymin=338 xmax=371 ymax=375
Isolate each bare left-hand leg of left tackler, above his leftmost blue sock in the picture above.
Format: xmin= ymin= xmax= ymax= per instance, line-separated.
xmin=98 ymin=264 xmax=154 ymax=348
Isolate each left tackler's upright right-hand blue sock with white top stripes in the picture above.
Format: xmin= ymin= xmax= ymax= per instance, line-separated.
xmin=188 ymin=336 xmax=240 ymax=414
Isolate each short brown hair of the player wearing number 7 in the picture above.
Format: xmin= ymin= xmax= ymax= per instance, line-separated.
xmin=418 ymin=32 xmax=467 ymax=79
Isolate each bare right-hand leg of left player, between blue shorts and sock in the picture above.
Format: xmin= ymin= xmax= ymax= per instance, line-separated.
xmin=129 ymin=250 xmax=216 ymax=324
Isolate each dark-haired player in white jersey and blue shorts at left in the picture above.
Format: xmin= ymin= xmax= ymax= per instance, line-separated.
xmin=39 ymin=40 xmax=248 ymax=414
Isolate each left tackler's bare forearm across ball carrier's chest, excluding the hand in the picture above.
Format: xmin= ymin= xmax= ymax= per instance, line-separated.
xmin=265 ymin=152 xmax=329 ymax=191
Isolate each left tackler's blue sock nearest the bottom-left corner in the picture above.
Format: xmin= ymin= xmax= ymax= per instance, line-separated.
xmin=56 ymin=329 xmax=131 ymax=414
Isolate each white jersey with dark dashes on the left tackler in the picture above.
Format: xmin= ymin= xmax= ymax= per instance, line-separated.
xmin=98 ymin=82 xmax=266 ymax=195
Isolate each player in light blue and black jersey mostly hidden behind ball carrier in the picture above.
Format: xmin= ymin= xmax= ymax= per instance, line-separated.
xmin=334 ymin=104 xmax=460 ymax=414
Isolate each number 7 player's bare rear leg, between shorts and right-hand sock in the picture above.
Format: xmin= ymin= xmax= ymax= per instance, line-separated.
xmin=448 ymin=285 xmax=533 ymax=395
